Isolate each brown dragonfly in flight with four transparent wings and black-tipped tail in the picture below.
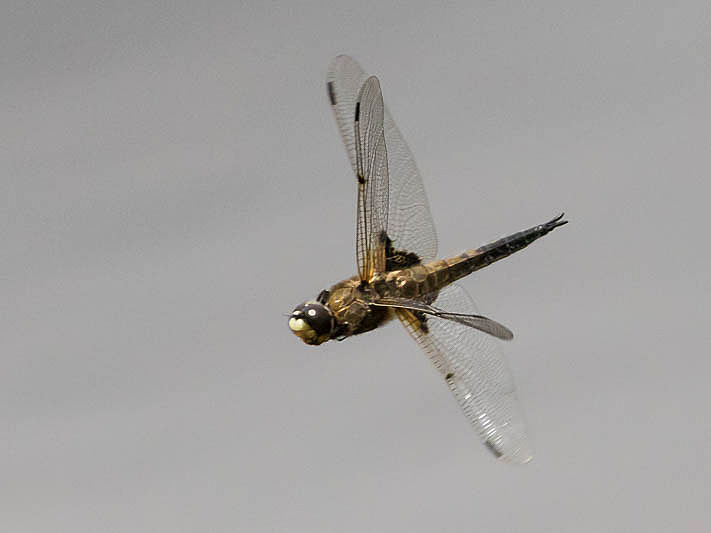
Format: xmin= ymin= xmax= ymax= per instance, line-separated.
xmin=288 ymin=55 xmax=567 ymax=463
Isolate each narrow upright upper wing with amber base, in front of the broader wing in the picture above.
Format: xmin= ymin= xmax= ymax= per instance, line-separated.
xmin=354 ymin=76 xmax=388 ymax=280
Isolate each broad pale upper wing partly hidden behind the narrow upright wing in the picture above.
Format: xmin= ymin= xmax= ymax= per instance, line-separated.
xmin=326 ymin=56 xmax=437 ymax=262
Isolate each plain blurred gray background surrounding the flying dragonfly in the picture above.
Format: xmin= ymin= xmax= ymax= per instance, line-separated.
xmin=0 ymin=1 xmax=711 ymax=532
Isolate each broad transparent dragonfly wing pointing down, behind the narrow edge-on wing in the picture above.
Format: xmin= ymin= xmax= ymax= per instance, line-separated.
xmin=395 ymin=284 xmax=532 ymax=463
